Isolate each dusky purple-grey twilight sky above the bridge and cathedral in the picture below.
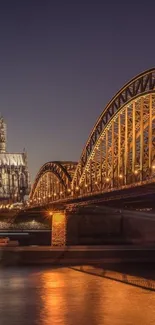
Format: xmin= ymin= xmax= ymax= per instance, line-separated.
xmin=0 ymin=0 xmax=155 ymax=181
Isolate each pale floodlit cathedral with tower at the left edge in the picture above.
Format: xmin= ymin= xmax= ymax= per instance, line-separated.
xmin=0 ymin=117 xmax=30 ymax=202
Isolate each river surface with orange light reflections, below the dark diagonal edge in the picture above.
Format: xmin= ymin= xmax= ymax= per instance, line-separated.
xmin=0 ymin=268 xmax=155 ymax=325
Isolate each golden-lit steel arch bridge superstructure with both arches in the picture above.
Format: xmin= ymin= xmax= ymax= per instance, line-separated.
xmin=30 ymin=68 xmax=155 ymax=202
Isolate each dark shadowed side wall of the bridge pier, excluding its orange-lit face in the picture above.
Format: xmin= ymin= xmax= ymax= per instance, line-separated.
xmin=66 ymin=206 xmax=122 ymax=246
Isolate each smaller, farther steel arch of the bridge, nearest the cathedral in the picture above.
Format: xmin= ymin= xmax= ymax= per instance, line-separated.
xmin=29 ymin=161 xmax=77 ymax=204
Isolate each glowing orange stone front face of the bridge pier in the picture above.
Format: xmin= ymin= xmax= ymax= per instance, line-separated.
xmin=51 ymin=211 xmax=66 ymax=246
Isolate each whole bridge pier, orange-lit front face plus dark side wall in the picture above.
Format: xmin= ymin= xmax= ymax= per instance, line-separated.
xmin=51 ymin=206 xmax=121 ymax=246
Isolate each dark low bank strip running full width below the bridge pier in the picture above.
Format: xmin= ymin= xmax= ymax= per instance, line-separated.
xmin=0 ymin=245 xmax=155 ymax=265
